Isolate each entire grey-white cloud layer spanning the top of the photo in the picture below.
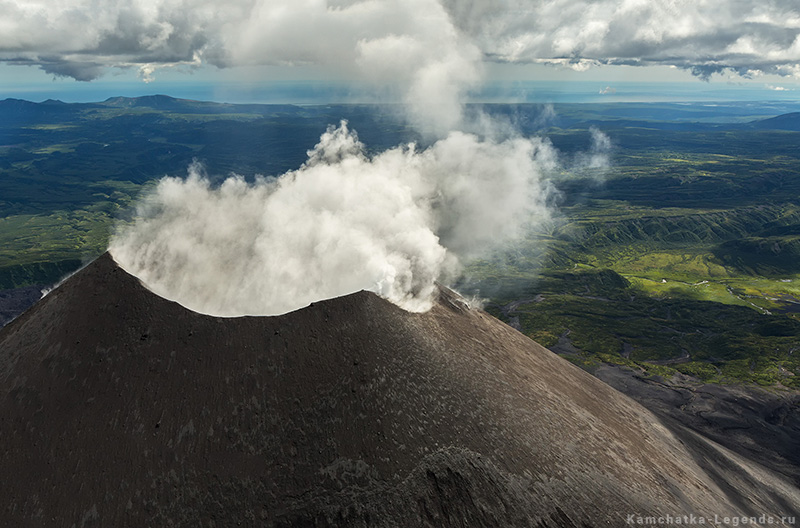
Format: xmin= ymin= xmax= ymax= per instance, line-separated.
xmin=0 ymin=0 xmax=800 ymax=91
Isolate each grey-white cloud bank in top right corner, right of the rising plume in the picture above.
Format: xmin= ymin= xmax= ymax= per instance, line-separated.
xmin=444 ymin=0 xmax=800 ymax=78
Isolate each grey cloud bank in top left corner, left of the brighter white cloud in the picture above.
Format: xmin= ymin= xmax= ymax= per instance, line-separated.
xmin=0 ymin=0 xmax=214 ymax=80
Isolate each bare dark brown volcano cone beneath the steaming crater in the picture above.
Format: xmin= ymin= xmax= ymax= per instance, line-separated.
xmin=0 ymin=254 xmax=800 ymax=527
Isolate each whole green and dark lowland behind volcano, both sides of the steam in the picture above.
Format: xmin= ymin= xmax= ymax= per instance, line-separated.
xmin=0 ymin=96 xmax=800 ymax=388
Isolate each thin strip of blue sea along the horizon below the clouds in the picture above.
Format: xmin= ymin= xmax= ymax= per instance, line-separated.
xmin=0 ymin=80 xmax=800 ymax=104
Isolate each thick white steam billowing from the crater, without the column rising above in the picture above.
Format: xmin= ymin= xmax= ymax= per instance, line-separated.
xmin=110 ymin=123 xmax=556 ymax=315
